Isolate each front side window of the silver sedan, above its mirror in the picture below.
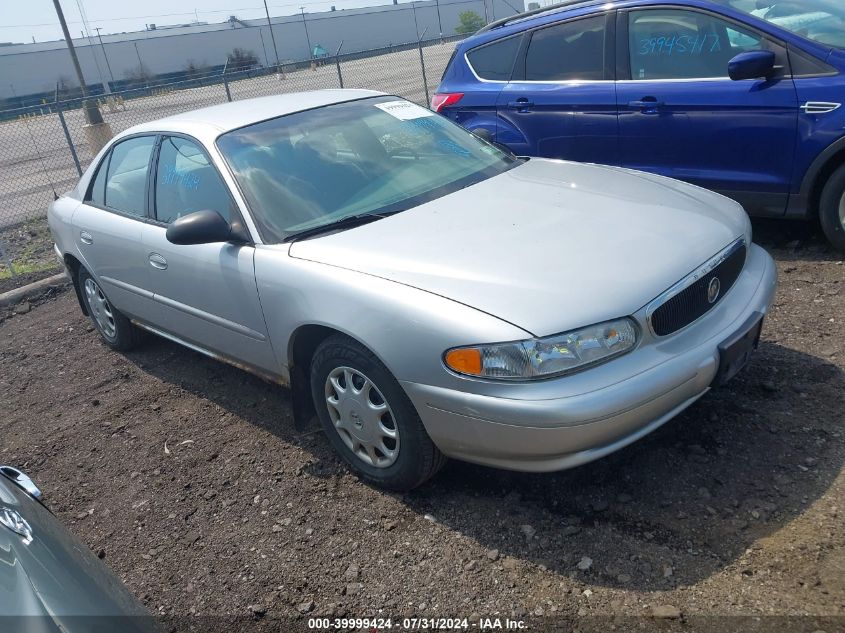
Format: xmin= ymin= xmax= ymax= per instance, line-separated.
xmin=155 ymin=136 xmax=232 ymax=224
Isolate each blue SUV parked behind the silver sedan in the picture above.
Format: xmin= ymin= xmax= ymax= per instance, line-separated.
xmin=431 ymin=0 xmax=845 ymax=250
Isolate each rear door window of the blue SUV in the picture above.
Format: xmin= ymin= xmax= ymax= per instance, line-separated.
xmin=525 ymin=16 xmax=606 ymax=81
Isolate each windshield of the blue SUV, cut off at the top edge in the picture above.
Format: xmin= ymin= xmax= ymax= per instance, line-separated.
xmin=722 ymin=0 xmax=845 ymax=48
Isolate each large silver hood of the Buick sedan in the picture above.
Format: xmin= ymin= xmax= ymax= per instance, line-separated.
xmin=290 ymin=159 xmax=749 ymax=336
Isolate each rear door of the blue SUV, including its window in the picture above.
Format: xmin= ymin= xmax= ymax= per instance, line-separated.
xmin=496 ymin=11 xmax=618 ymax=164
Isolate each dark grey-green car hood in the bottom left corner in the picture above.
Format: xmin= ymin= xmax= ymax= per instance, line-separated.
xmin=0 ymin=475 xmax=159 ymax=633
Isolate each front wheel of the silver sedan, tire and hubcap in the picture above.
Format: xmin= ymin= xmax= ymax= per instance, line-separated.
xmin=311 ymin=335 xmax=446 ymax=491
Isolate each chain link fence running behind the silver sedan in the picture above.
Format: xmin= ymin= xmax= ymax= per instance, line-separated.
xmin=0 ymin=37 xmax=460 ymax=292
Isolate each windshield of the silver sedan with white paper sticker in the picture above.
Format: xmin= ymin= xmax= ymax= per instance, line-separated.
xmin=217 ymin=97 xmax=517 ymax=242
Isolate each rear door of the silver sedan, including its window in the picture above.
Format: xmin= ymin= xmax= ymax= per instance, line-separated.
xmin=73 ymin=135 xmax=156 ymax=319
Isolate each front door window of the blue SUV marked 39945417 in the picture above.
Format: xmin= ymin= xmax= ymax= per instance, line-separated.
xmin=628 ymin=9 xmax=787 ymax=80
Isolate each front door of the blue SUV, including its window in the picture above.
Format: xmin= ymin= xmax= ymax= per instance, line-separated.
xmin=617 ymin=8 xmax=799 ymax=215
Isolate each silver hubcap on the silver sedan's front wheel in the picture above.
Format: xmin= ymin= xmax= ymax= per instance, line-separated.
xmin=326 ymin=367 xmax=399 ymax=468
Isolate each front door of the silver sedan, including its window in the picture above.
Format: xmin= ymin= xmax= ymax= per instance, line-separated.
xmin=142 ymin=136 xmax=278 ymax=373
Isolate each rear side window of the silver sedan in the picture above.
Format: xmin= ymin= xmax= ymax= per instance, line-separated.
xmin=103 ymin=136 xmax=155 ymax=216
